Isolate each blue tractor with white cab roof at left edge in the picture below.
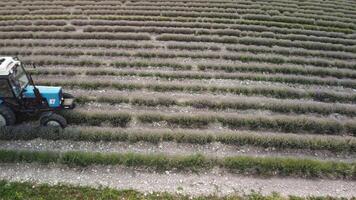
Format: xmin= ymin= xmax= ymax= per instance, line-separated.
xmin=0 ymin=57 xmax=75 ymax=128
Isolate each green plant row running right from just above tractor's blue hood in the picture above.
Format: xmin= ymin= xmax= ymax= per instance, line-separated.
xmin=38 ymin=80 xmax=356 ymax=103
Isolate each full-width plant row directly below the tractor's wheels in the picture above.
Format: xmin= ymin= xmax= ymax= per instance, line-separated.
xmin=0 ymin=126 xmax=356 ymax=154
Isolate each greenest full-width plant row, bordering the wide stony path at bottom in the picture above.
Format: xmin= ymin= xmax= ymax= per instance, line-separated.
xmin=0 ymin=150 xmax=356 ymax=179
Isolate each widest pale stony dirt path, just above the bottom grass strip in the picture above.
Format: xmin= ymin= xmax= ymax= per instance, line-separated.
xmin=0 ymin=164 xmax=356 ymax=198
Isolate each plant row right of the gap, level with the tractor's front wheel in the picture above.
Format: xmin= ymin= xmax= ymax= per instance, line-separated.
xmin=136 ymin=113 xmax=356 ymax=136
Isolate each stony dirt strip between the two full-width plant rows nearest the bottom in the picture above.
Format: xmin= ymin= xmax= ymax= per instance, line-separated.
xmin=0 ymin=139 xmax=356 ymax=162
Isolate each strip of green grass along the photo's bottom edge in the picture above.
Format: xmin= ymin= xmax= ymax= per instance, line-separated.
xmin=0 ymin=180 xmax=320 ymax=200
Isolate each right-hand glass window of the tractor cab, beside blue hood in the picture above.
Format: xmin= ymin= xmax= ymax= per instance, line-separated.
xmin=9 ymin=65 xmax=29 ymax=96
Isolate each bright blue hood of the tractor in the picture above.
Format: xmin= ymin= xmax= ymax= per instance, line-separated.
xmin=23 ymin=85 xmax=62 ymax=108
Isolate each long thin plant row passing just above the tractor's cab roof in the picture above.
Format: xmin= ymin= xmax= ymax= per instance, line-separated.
xmin=10 ymin=49 xmax=356 ymax=69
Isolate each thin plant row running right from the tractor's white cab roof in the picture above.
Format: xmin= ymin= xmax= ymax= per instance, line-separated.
xmin=23 ymin=57 xmax=356 ymax=79
